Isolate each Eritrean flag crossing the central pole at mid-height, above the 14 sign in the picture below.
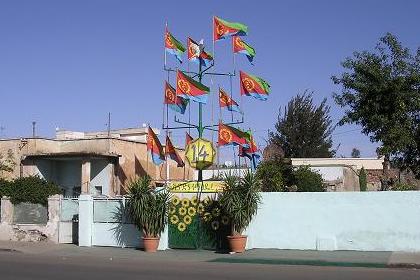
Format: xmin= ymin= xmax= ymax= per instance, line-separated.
xmin=176 ymin=70 xmax=210 ymax=104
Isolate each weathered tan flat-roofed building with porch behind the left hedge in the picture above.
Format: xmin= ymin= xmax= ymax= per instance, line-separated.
xmin=0 ymin=128 xmax=193 ymax=196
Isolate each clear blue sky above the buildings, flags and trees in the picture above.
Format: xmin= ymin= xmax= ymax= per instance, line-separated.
xmin=0 ymin=0 xmax=420 ymax=156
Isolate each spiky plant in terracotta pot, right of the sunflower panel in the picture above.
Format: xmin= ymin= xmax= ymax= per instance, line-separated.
xmin=219 ymin=171 xmax=261 ymax=253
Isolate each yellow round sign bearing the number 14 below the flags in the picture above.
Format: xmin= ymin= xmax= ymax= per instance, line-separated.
xmin=185 ymin=138 xmax=216 ymax=170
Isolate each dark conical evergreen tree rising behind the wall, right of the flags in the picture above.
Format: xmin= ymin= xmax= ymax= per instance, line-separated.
xmin=269 ymin=91 xmax=335 ymax=158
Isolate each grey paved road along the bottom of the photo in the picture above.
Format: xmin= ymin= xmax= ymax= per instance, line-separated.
xmin=0 ymin=252 xmax=420 ymax=280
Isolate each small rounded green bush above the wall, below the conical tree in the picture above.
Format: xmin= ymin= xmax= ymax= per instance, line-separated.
xmin=293 ymin=166 xmax=326 ymax=192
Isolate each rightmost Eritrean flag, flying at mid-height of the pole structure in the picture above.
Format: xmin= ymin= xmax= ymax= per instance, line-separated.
xmin=239 ymin=71 xmax=270 ymax=101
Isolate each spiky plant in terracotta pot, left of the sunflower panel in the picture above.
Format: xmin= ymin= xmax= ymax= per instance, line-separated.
xmin=127 ymin=175 xmax=170 ymax=252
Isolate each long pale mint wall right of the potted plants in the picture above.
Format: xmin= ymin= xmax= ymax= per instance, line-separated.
xmin=247 ymin=191 xmax=420 ymax=252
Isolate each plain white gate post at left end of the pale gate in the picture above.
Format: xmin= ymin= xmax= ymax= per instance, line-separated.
xmin=79 ymin=194 xmax=93 ymax=247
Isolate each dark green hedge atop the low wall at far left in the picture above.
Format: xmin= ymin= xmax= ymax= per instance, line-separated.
xmin=0 ymin=176 xmax=62 ymax=206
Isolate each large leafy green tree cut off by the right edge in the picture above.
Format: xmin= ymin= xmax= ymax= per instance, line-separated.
xmin=332 ymin=33 xmax=420 ymax=177
